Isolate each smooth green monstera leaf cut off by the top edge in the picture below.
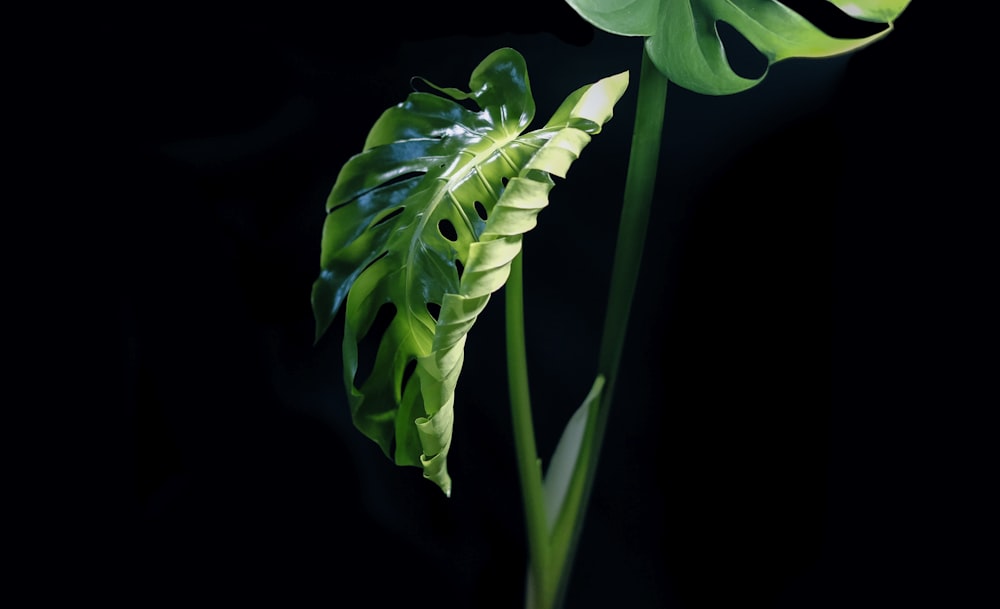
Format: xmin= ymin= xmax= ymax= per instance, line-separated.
xmin=566 ymin=0 xmax=910 ymax=95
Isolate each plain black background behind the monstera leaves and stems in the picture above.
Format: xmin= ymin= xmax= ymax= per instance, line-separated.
xmin=29 ymin=2 xmax=996 ymax=609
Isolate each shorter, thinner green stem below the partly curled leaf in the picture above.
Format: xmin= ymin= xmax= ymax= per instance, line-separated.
xmin=504 ymin=247 xmax=553 ymax=609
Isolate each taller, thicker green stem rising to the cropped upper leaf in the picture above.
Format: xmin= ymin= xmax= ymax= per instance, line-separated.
xmin=553 ymin=48 xmax=668 ymax=608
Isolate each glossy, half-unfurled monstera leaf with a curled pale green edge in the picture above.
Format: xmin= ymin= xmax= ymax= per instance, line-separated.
xmin=312 ymin=49 xmax=628 ymax=494
